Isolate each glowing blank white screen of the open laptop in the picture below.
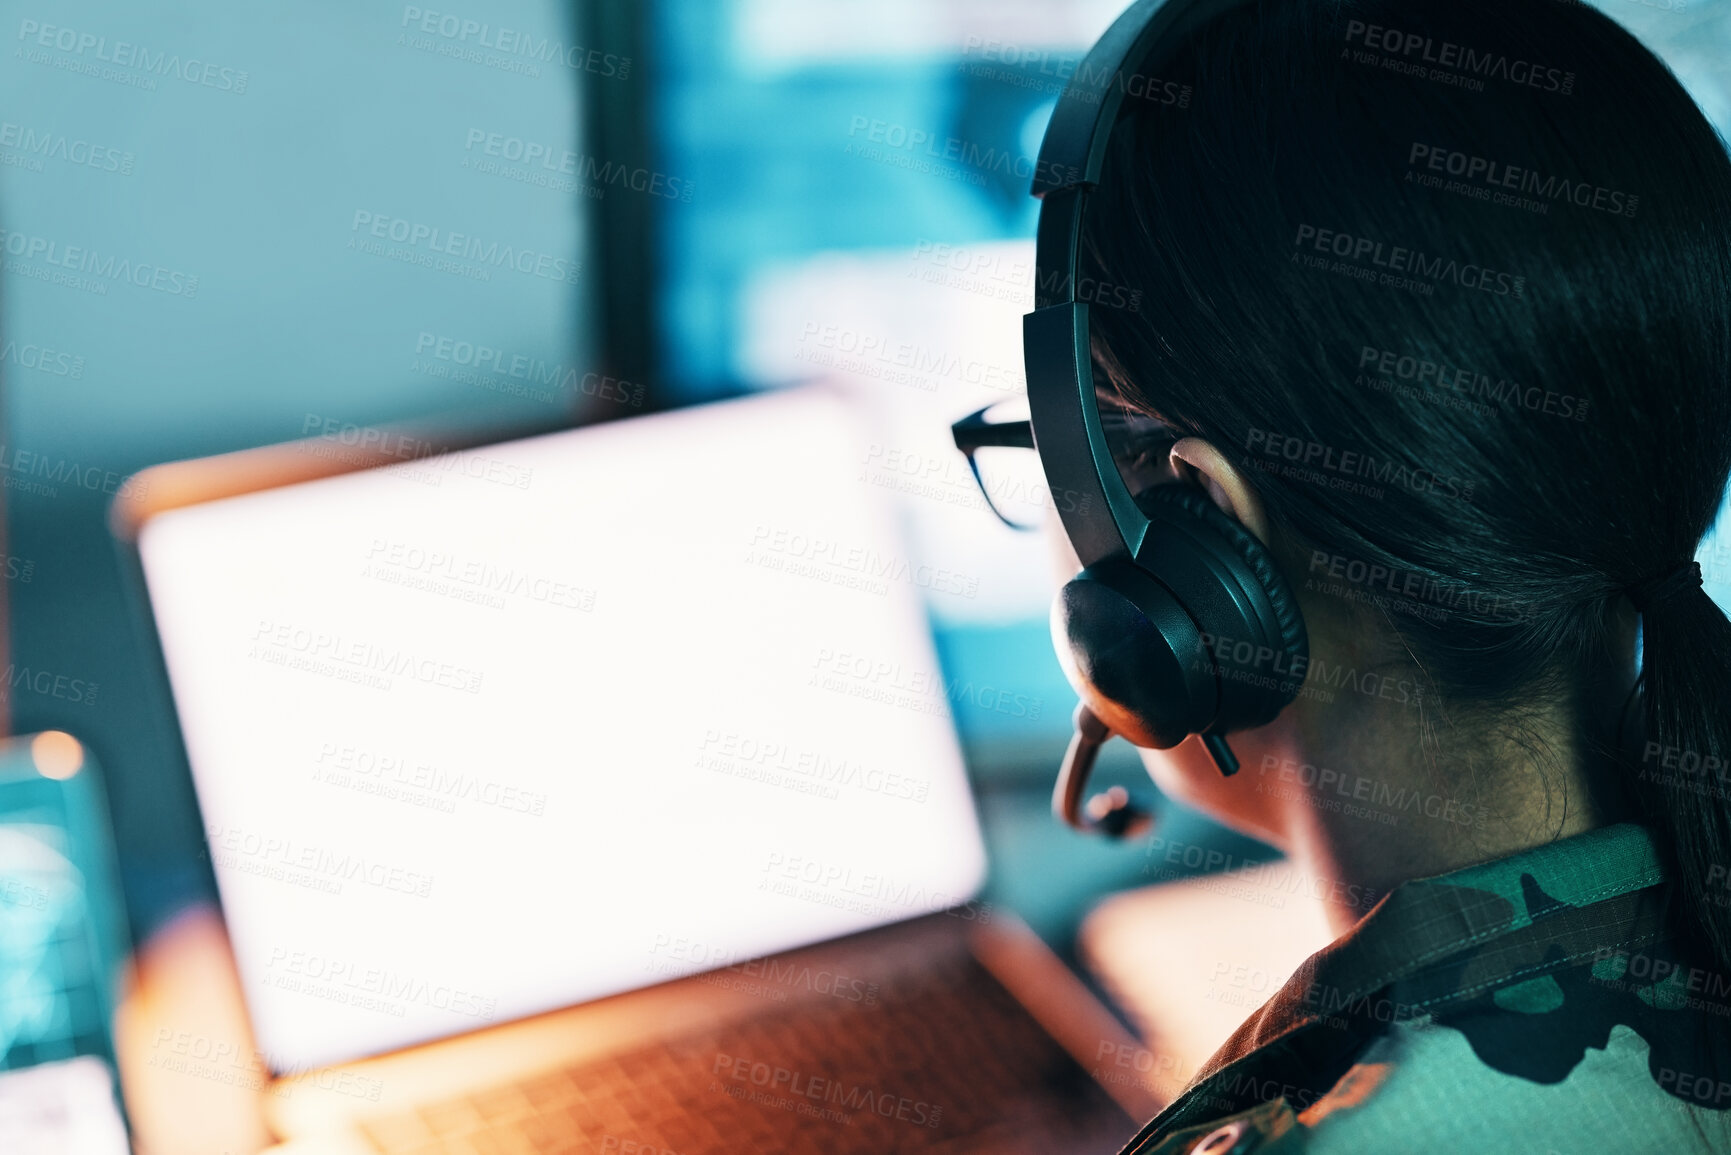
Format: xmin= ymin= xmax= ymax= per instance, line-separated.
xmin=138 ymin=390 xmax=985 ymax=1070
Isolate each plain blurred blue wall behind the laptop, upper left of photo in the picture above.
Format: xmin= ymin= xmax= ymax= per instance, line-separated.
xmin=0 ymin=0 xmax=595 ymax=925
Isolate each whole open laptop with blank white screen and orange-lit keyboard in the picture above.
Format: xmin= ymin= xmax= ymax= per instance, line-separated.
xmin=114 ymin=388 xmax=1160 ymax=1155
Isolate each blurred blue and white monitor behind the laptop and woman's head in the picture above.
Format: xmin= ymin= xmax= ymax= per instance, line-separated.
xmin=653 ymin=0 xmax=1731 ymax=776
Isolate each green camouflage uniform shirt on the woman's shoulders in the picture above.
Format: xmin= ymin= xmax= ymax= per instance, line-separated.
xmin=1125 ymin=824 xmax=1731 ymax=1155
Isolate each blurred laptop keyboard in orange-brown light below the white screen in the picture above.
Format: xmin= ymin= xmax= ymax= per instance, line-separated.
xmin=354 ymin=954 xmax=1141 ymax=1155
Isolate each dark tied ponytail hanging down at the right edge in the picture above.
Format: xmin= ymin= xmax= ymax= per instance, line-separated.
xmin=1629 ymin=563 xmax=1731 ymax=970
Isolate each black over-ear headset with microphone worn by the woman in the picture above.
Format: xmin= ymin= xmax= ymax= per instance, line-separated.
xmin=1021 ymin=0 xmax=1309 ymax=836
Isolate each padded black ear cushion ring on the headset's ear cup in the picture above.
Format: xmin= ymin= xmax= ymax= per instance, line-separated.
xmin=1136 ymin=483 xmax=1310 ymax=729
